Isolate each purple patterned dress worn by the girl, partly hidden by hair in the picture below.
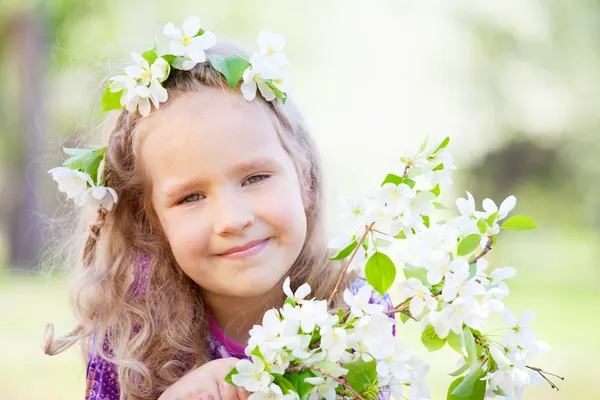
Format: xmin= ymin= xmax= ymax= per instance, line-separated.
xmin=85 ymin=276 xmax=395 ymax=400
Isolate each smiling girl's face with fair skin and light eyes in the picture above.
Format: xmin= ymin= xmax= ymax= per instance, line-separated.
xmin=140 ymin=88 xmax=306 ymax=297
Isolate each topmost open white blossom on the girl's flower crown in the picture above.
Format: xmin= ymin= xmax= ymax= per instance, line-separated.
xmin=163 ymin=17 xmax=217 ymax=70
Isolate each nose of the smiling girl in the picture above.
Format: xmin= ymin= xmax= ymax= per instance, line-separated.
xmin=213 ymin=193 xmax=255 ymax=236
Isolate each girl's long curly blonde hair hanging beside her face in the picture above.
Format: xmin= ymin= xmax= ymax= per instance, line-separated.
xmin=44 ymin=42 xmax=351 ymax=400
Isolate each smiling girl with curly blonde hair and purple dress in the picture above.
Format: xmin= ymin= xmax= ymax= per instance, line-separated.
xmin=45 ymin=21 xmax=391 ymax=400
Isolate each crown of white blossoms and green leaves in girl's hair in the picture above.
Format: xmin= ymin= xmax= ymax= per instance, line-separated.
xmin=48 ymin=16 xmax=292 ymax=211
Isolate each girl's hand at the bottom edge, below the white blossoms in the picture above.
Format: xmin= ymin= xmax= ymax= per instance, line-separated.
xmin=158 ymin=357 xmax=249 ymax=400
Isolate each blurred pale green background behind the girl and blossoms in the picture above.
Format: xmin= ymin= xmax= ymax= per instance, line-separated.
xmin=0 ymin=0 xmax=600 ymax=400
